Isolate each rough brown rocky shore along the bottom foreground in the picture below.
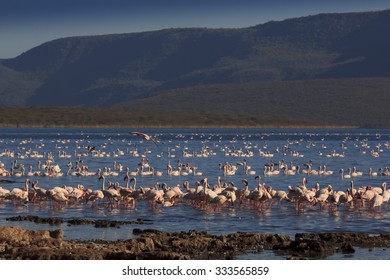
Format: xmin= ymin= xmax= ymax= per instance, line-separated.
xmin=0 ymin=223 xmax=390 ymax=260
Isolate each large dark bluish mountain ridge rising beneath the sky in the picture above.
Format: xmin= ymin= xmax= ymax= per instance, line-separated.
xmin=0 ymin=10 xmax=390 ymax=125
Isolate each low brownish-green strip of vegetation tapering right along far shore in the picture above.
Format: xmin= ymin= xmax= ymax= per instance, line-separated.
xmin=0 ymin=107 xmax=321 ymax=128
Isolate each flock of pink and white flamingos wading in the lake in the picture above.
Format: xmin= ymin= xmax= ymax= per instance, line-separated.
xmin=0 ymin=132 xmax=390 ymax=212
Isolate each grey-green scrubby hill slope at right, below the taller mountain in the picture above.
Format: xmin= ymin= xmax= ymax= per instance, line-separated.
xmin=122 ymin=78 xmax=390 ymax=127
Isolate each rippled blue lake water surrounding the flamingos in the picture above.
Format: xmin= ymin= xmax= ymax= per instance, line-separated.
xmin=0 ymin=128 xmax=390 ymax=259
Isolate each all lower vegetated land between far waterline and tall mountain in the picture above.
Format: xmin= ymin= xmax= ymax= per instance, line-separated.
xmin=0 ymin=78 xmax=390 ymax=128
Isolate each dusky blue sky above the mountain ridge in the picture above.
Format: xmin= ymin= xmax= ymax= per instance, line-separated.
xmin=0 ymin=0 xmax=390 ymax=58
